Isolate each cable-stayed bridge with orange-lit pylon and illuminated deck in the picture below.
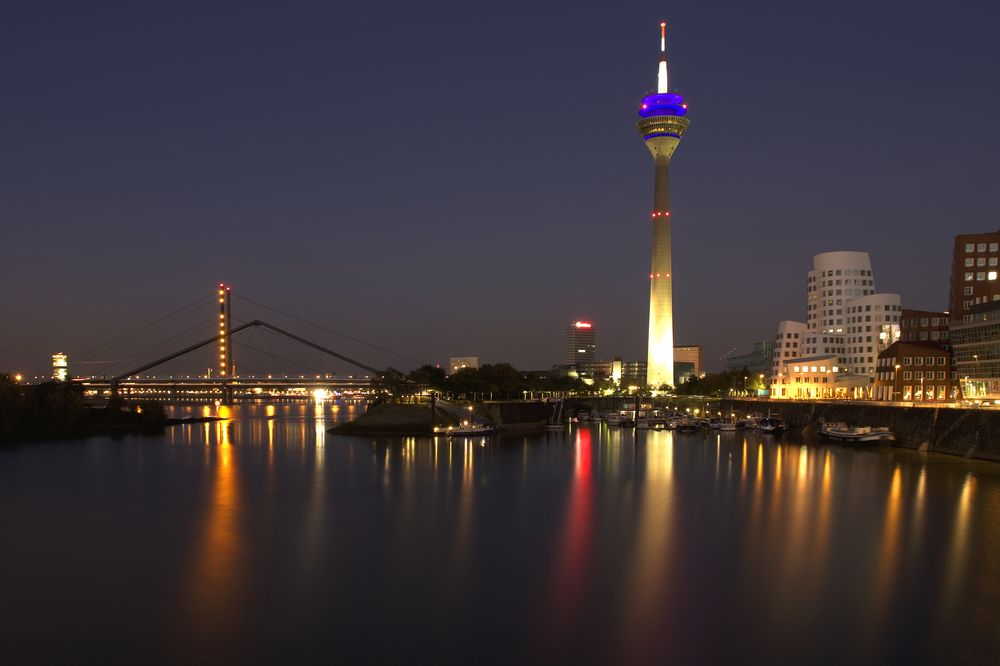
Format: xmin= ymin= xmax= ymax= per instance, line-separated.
xmin=62 ymin=284 xmax=422 ymax=403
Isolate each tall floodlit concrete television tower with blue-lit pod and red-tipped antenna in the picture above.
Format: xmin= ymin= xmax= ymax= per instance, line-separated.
xmin=636 ymin=23 xmax=689 ymax=386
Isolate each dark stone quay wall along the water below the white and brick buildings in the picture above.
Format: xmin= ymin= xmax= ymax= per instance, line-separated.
xmin=722 ymin=400 xmax=1000 ymax=461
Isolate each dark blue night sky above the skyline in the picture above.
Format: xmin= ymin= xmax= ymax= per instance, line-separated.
xmin=0 ymin=0 xmax=1000 ymax=370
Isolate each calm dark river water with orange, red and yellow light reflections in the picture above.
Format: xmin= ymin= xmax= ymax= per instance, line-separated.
xmin=0 ymin=402 xmax=1000 ymax=664
